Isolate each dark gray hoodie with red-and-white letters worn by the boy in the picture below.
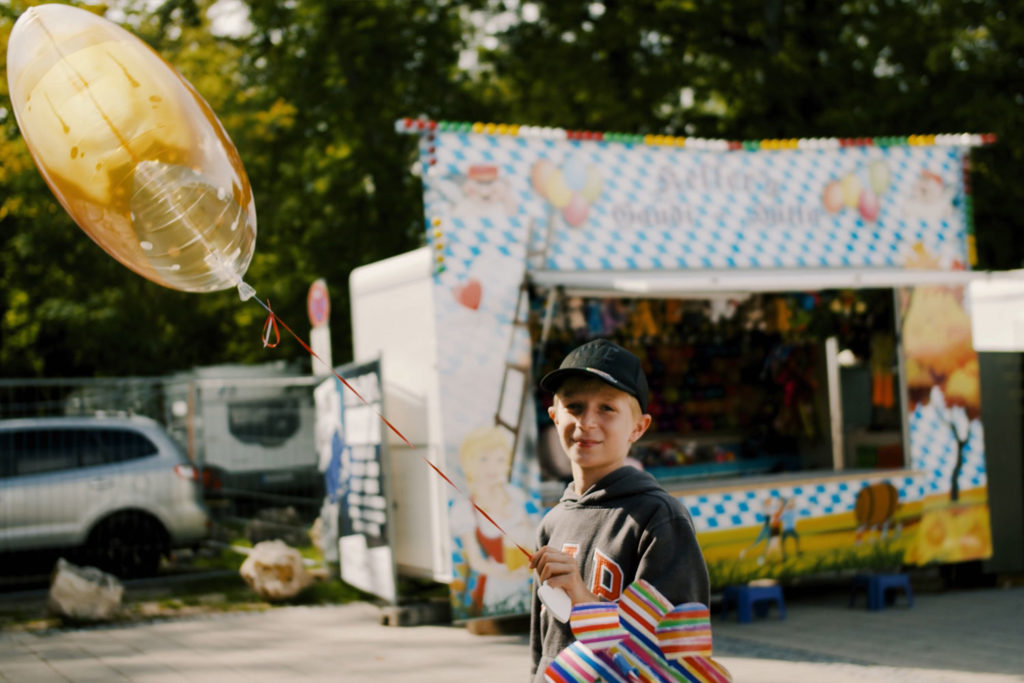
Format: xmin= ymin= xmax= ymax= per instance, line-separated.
xmin=529 ymin=466 xmax=711 ymax=683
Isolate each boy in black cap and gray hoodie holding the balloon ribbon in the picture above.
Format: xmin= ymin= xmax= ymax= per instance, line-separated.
xmin=529 ymin=339 xmax=710 ymax=682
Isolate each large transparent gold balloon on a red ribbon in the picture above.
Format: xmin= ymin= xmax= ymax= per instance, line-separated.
xmin=7 ymin=5 xmax=256 ymax=292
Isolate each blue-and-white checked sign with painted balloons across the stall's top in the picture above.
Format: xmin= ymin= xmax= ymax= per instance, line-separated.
xmin=424 ymin=132 xmax=967 ymax=270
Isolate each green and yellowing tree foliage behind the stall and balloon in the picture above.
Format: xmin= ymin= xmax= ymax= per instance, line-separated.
xmin=0 ymin=0 xmax=1024 ymax=377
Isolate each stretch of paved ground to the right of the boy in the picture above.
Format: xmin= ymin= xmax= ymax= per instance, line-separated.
xmin=712 ymin=587 xmax=1024 ymax=683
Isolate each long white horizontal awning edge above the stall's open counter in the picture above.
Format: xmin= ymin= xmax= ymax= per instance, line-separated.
xmin=528 ymin=268 xmax=1024 ymax=298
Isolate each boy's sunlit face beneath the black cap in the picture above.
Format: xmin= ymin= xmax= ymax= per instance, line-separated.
xmin=548 ymin=379 xmax=651 ymax=483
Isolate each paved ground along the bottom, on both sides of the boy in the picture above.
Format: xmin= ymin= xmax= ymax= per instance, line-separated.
xmin=0 ymin=587 xmax=1024 ymax=683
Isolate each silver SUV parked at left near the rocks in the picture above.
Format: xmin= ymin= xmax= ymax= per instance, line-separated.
xmin=0 ymin=417 xmax=210 ymax=579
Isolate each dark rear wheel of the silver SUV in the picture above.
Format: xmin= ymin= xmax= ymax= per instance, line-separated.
xmin=86 ymin=513 xmax=168 ymax=579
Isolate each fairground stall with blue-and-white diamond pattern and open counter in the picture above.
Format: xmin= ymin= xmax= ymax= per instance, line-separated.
xmin=350 ymin=120 xmax=1003 ymax=618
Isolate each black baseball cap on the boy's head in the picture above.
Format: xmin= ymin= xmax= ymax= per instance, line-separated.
xmin=541 ymin=339 xmax=649 ymax=413
